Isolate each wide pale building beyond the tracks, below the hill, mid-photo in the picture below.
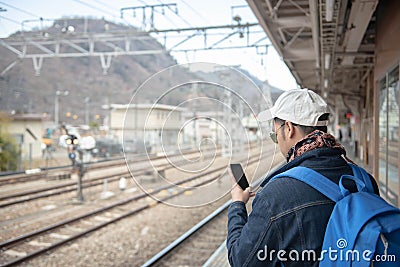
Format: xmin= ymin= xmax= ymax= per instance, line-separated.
xmin=110 ymin=104 xmax=185 ymax=152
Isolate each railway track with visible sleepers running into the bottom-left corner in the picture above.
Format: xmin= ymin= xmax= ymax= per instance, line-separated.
xmin=0 ymin=155 xmax=266 ymax=266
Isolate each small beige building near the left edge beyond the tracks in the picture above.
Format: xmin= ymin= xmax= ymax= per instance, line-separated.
xmin=7 ymin=114 xmax=44 ymax=160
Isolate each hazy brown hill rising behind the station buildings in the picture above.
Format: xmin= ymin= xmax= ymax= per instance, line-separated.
xmin=0 ymin=18 xmax=282 ymax=124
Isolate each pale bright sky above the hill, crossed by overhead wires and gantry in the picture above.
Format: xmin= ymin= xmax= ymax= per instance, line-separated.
xmin=0 ymin=0 xmax=296 ymax=90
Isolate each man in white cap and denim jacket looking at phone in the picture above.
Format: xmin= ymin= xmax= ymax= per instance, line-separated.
xmin=227 ymin=89 xmax=378 ymax=267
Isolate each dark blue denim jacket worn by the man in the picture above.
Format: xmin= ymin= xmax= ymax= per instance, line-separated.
xmin=227 ymin=148 xmax=378 ymax=267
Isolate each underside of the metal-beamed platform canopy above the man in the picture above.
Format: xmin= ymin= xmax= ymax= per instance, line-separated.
xmin=247 ymin=0 xmax=378 ymax=107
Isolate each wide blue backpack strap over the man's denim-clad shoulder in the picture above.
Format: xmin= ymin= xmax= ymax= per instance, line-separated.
xmin=269 ymin=166 xmax=343 ymax=202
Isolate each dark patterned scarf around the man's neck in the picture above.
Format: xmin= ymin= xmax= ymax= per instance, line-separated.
xmin=286 ymin=130 xmax=346 ymax=162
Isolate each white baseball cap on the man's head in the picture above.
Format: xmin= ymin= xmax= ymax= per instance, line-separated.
xmin=257 ymin=89 xmax=329 ymax=126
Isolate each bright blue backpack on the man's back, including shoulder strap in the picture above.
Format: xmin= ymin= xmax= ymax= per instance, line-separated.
xmin=271 ymin=164 xmax=400 ymax=267
